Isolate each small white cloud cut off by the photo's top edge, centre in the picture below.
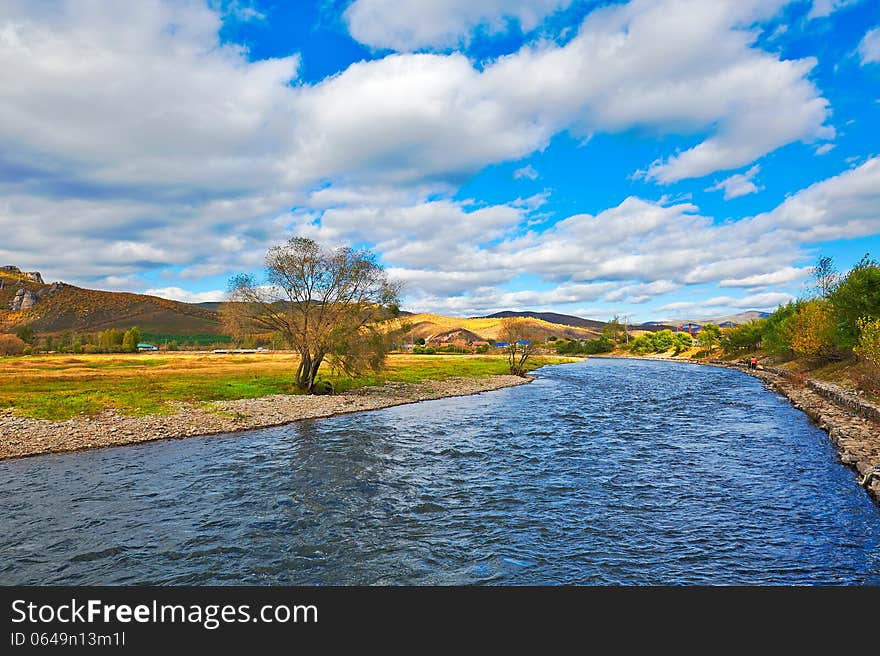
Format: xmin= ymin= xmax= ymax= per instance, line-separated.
xmin=344 ymin=0 xmax=572 ymax=52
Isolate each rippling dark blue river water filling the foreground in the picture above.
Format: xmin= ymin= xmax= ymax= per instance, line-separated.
xmin=0 ymin=359 xmax=880 ymax=584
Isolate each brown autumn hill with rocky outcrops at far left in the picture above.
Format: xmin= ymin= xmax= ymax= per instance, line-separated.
xmin=0 ymin=266 xmax=221 ymax=335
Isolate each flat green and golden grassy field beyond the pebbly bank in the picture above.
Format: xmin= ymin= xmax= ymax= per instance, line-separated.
xmin=0 ymin=353 xmax=570 ymax=420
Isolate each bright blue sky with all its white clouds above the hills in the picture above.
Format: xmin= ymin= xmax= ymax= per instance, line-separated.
xmin=0 ymin=0 xmax=880 ymax=321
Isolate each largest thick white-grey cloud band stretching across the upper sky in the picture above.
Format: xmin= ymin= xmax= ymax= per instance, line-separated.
xmin=0 ymin=0 xmax=833 ymax=197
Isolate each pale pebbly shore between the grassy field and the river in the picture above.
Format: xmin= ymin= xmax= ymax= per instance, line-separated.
xmin=0 ymin=376 xmax=532 ymax=460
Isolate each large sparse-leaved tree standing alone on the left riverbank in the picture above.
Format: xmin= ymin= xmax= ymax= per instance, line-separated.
xmin=222 ymin=237 xmax=400 ymax=393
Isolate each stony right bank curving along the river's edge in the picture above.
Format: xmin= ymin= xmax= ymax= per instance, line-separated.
xmin=591 ymin=355 xmax=880 ymax=504
